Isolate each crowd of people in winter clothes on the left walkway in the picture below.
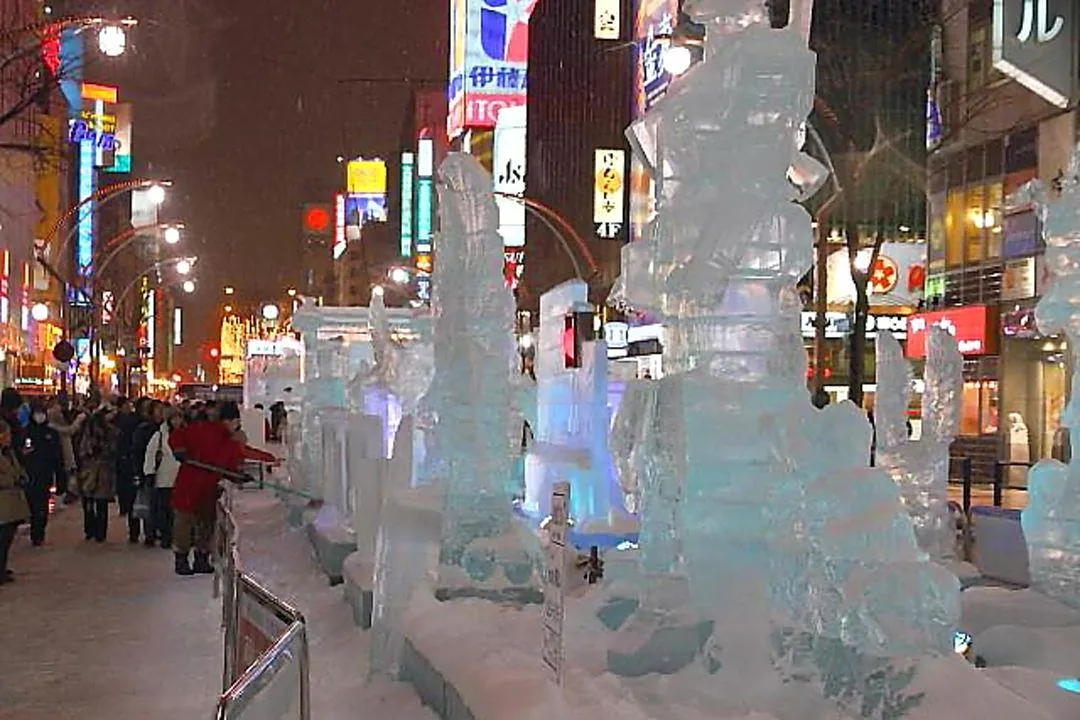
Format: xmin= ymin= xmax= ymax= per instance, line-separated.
xmin=0 ymin=388 xmax=274 ymax=585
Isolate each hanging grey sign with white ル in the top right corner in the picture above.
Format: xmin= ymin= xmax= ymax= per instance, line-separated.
xmin=994 ymin=0 xmax=1080 ymax=108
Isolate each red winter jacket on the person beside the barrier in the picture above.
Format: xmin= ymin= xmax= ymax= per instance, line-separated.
xmin=168 ymin=420 xmax=244 ymax=518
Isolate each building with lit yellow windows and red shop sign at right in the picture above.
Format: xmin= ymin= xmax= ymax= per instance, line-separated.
xmin=924 ymin=0 xmax=1080 ymax=484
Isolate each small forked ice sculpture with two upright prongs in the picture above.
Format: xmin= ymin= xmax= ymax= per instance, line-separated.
xmin=875 ymin=327 xmax=963 ymax=561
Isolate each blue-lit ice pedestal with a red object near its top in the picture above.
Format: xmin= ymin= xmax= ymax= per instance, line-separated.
xmin=524 ymin=280 xmax=632 ymax=535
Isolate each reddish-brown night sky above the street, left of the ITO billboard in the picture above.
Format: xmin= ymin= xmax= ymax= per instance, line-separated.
xmin=107 ymin=0 xmax=448 ymax=369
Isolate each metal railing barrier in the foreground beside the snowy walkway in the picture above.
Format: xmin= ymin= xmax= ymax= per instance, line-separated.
xmin=214 ymin=489 xmax=311 ymax=720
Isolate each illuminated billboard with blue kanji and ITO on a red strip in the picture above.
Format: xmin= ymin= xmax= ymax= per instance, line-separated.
xmin=447 ymin=0 xmax=538 ymax=138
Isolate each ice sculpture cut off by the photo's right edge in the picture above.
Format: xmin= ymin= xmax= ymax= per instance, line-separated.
xmin=1021 ymin=146 xmax=1080 ymax=608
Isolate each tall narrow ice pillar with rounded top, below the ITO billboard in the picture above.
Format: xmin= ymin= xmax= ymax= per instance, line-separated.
xmin=421 ymin=153 xmax=539 ymax=600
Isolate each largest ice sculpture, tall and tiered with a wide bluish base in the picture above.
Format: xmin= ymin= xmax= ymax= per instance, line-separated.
xmin=608 ymin=0 xmax=959 ymax=703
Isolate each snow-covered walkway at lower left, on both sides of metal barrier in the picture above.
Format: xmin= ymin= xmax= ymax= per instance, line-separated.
xmin=0 ymin=491 xmax=434 ymax=720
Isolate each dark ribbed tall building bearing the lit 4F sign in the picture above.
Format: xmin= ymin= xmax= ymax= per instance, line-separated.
xmin=520 ymin=0 xmax=635 ymax=310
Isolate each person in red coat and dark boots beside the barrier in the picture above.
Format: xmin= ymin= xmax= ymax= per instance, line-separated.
xmin=168 ymin=403 xmax=246 ymax=575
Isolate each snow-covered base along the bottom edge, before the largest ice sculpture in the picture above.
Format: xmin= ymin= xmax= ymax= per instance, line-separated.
xmin=401 ymin=590 xmax=1062 ymax=720
